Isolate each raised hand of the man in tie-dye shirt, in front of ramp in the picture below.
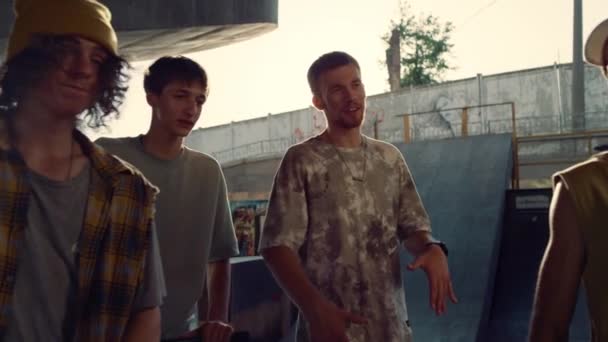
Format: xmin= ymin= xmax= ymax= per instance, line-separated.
xmin=407 ymin=245 xmax=458 ymax=315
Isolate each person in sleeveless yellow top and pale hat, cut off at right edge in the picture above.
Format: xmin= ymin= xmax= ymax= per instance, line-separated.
xmin=530 ymin=19 xmax=608 ymax=342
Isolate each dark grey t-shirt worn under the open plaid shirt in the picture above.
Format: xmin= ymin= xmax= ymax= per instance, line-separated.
xmin=4 ymin=163 xmax=164 ymax=341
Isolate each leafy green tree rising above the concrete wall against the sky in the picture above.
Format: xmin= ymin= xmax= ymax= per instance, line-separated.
xmin=382 ymin=1 xmax=453 ymax=90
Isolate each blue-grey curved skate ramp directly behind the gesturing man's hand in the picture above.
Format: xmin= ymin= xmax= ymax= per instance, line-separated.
xmin=396 ymin=134 xmax=512 ymax=342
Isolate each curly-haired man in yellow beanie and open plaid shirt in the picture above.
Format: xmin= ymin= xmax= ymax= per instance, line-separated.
xmin=0 ymin=0 xmax=164 ymax=341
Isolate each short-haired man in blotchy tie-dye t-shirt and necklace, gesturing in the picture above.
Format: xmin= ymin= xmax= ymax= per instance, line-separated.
xmin=260 ymin=52 xmax=456 ymax=342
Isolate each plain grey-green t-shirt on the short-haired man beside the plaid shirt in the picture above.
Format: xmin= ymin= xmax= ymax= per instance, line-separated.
xmin=96 ymin=136 xmax=238 ymax=338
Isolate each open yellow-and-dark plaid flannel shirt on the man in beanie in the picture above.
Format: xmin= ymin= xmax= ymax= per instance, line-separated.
xmin=0 ymin=130 xmax=158 ymax=341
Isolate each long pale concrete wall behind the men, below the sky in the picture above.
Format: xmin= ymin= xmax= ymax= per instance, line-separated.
xmin=187 ymin=64 xmax=608 ymax=163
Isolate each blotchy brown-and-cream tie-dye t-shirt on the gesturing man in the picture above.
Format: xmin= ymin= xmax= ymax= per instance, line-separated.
xmin=260 ymin=136 xmax=430 ymax=342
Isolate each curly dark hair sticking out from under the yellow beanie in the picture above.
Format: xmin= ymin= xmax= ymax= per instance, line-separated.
xmin=0 ymin=34 xmax=131 ymax=128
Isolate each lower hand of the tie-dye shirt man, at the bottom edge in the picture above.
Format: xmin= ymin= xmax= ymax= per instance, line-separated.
xmin=305 ymin=299 xmax=367 ymax=342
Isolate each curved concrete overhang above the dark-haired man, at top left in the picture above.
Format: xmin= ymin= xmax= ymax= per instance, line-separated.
xmin=0 ymin=0 xmax=279 ymax=61
